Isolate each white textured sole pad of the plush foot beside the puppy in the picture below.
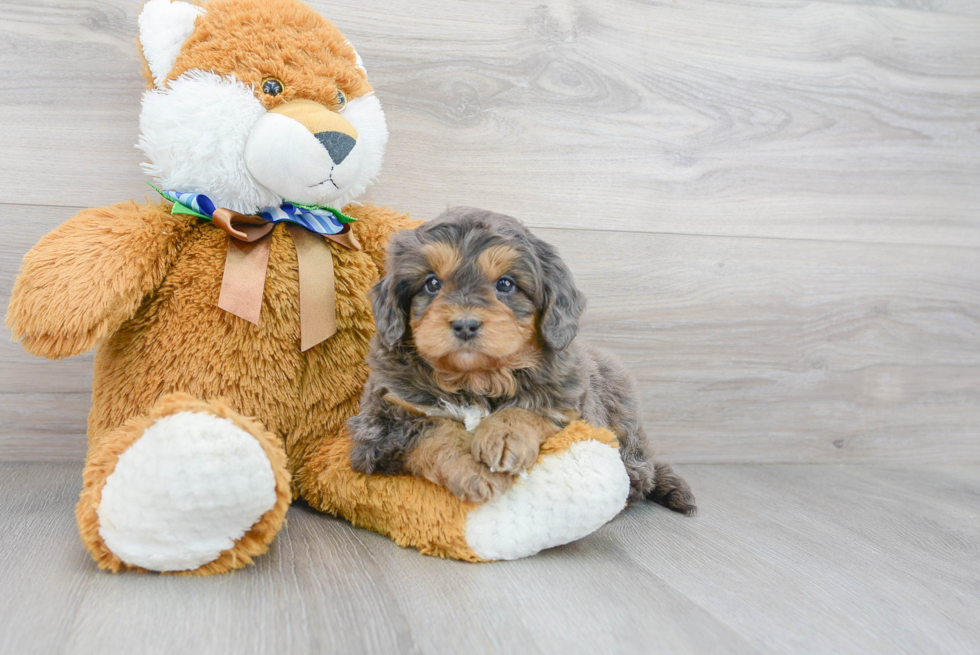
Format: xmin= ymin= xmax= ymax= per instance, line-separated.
xmin=466 ymin=441 xmax=630 ymax=560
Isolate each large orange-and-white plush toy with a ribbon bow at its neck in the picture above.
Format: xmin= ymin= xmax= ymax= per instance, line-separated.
xmin=7 ymin=0 xmax=629 ymax=574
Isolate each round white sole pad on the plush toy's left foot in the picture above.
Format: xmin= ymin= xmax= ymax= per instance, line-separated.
xmin=98 ymin=412 xmax=276 ymax=571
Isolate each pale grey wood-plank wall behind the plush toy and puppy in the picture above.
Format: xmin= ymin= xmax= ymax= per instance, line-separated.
xmin=0 ymin=0 xmax=980 ymax=463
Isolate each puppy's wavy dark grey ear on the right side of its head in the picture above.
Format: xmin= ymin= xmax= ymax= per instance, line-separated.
xmin=532 ymin=237 xmax=585 ymax=350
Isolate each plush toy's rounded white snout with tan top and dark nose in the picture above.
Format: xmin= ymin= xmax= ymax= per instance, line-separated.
xmin=245 ymin=100 xmax=365 ymax=205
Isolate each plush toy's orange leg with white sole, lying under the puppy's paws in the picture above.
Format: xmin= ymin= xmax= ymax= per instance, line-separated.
xmin=297 ymin=421 xmax=630 ymax=562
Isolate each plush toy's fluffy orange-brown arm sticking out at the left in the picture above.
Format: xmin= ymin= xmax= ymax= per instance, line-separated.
xmin=6 ymin=202 xmax=193 ymax=359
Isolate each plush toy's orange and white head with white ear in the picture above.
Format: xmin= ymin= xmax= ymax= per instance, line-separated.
xmin=138 ymin=0 xmax=388 ymax=213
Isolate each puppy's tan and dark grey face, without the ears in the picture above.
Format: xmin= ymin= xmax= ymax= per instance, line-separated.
xmin=409 ymin=241 xmax=540 ymax=373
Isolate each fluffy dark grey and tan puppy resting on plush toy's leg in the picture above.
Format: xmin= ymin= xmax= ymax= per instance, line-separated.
xmin=349 ymin=207 xmax=695 ymax=514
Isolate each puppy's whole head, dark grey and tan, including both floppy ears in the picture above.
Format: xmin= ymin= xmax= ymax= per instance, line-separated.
xmin=373 ymin=207 xmax=585 ymax=382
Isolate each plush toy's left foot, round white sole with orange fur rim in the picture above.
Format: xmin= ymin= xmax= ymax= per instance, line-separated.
xmin=76 ymin=394 xmax=291 ymax=575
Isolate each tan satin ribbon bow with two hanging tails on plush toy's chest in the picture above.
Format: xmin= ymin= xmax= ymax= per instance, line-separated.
xmin=212 ymin=207 xmax=361 ymax=351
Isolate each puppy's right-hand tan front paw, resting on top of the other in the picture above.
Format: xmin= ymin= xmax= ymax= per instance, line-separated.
xmin=470 ymin=409 xmax=558 ymax=473
